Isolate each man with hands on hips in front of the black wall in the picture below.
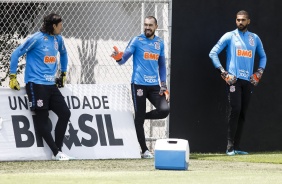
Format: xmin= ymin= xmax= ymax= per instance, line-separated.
xmin=209 ymin=10 xmax=266 ymax=156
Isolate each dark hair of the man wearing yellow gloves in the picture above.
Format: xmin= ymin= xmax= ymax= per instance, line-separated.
xmin=40 ymin=13 xmax=62 ymax=34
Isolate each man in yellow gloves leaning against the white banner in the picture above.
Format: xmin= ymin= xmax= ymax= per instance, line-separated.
xmin=9 ymin=13 xmax=72 ymax=160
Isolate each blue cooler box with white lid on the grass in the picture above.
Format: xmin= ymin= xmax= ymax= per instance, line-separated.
xmin=155 ymin=139 xmax=189 ymax=170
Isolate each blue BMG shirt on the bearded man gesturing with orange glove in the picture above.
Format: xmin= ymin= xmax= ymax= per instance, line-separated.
xmin=118 ymin=34 xmax=166 ymax=86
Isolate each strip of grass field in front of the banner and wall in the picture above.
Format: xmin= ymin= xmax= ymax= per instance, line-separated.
xmin=0 ymin=152 xmax=282 ymax=184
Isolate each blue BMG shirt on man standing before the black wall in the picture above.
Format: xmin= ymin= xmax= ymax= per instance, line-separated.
xmin=209 ymin=29 xmax=266 ymax=81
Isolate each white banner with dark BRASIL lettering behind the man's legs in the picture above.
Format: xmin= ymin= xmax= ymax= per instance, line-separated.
xmin=0 ymin=84 xmax=140 ymax=161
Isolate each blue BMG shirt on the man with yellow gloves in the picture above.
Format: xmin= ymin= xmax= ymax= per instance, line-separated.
xmin=10 ymin=32 xmax=68 ymax=85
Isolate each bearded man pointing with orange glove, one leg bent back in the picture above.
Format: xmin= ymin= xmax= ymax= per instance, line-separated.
xmin=112 ymin=16 xmax=169 ymax=158
